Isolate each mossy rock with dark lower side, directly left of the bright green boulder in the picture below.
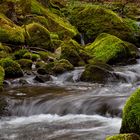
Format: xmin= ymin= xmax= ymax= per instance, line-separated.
xmin=60 ymin=39 xmax=84 ymax=66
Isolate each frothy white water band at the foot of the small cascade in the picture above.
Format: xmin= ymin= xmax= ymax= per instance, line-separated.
xmin=0 ymin=114 xmax=121 ymax=140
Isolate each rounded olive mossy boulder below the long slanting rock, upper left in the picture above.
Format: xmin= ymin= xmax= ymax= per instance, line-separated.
xmin=26 ymin=23 xmax=53 ymax=51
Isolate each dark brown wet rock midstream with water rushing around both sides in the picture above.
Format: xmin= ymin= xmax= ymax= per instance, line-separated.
xmin=80 ymin=62 xmax=114 ymax=83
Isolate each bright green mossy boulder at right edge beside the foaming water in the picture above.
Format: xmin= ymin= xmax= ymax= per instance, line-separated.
xmin=120 ymin=89 xmax=140 ymax=135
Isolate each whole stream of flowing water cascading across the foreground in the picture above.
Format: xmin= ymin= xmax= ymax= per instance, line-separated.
xmin=0 ymin=60 xmax=140 ymax=140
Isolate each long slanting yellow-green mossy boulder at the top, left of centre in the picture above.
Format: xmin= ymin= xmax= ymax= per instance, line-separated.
xmin=31 ymin=0 xmax=78 ymax=40
